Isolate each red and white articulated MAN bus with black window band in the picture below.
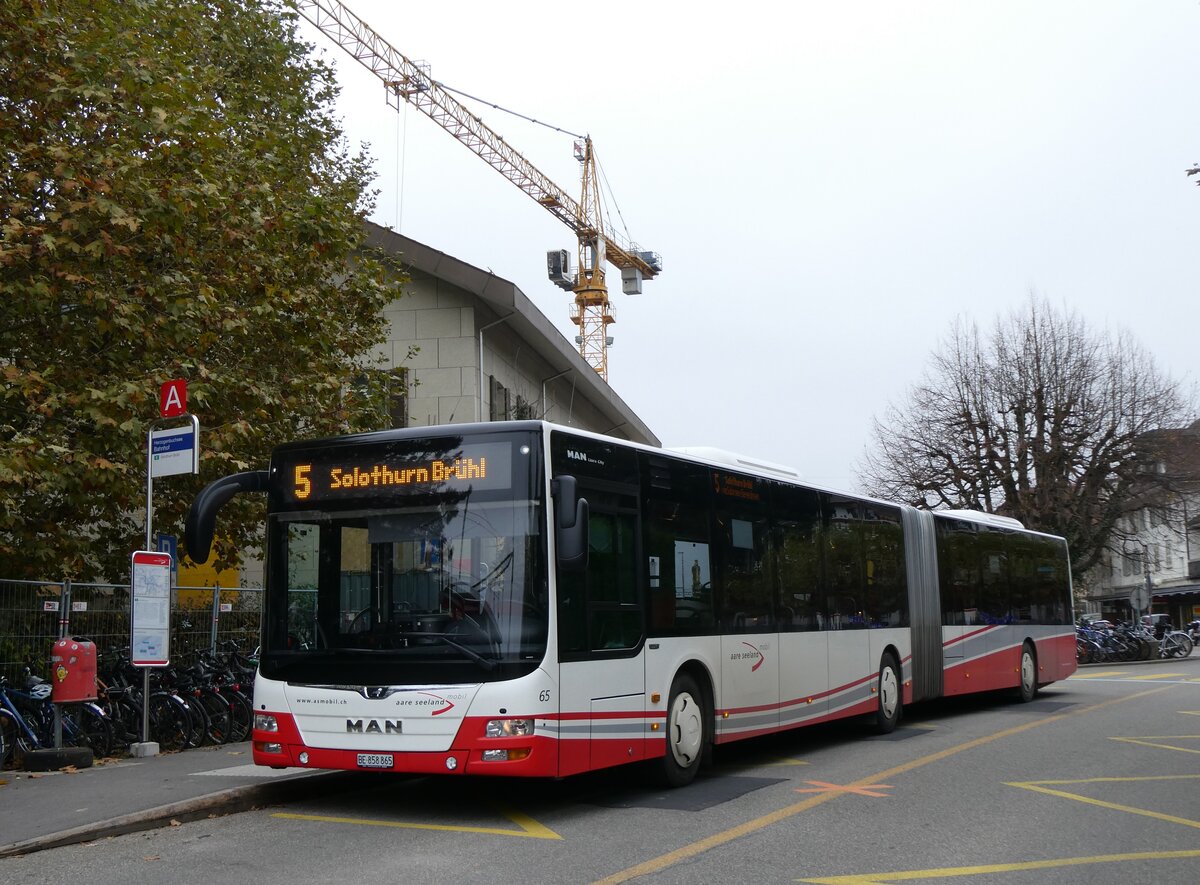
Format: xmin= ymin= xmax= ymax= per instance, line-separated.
xmin=186 ymin=421 xmax=1075 ymax=785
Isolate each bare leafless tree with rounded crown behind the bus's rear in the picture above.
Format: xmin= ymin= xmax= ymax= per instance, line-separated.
xmin=859 ymin=296 xmax=1190 ymax=574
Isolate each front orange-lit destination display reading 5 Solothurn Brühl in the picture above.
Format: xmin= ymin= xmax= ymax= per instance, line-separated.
xmin=280 ymin=443 xmax=512 ymax=502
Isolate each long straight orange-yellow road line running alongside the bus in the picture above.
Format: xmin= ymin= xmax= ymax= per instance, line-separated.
xmin=594 ymin=687 xmax=1168 ymax=885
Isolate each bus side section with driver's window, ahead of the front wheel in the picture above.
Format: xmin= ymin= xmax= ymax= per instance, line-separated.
xmin=557 ymin=483 xmax=646 ymax=775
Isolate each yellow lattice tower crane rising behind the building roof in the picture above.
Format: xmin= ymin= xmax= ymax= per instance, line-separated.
xmin=293 ymin=0 xmax=662 ymax=380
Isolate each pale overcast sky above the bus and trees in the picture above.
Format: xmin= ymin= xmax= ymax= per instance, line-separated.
xmin=295 ymin=0 xmax=1200 ymax=489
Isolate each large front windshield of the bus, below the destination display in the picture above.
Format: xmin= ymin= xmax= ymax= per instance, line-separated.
xmin=262 ymin=431 xmax=548 ymax=685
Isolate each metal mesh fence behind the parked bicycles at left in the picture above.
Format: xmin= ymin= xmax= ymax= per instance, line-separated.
xmin=0 ymin=579 xmax=263 ymax=679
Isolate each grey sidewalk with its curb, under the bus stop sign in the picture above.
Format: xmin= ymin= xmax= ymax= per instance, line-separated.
xmin=0 ymin=742 xmax=353 ymax=857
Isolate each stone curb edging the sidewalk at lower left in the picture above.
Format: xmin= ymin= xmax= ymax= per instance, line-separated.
xmin=0 ymin=771 xmax=355 ymax=859
